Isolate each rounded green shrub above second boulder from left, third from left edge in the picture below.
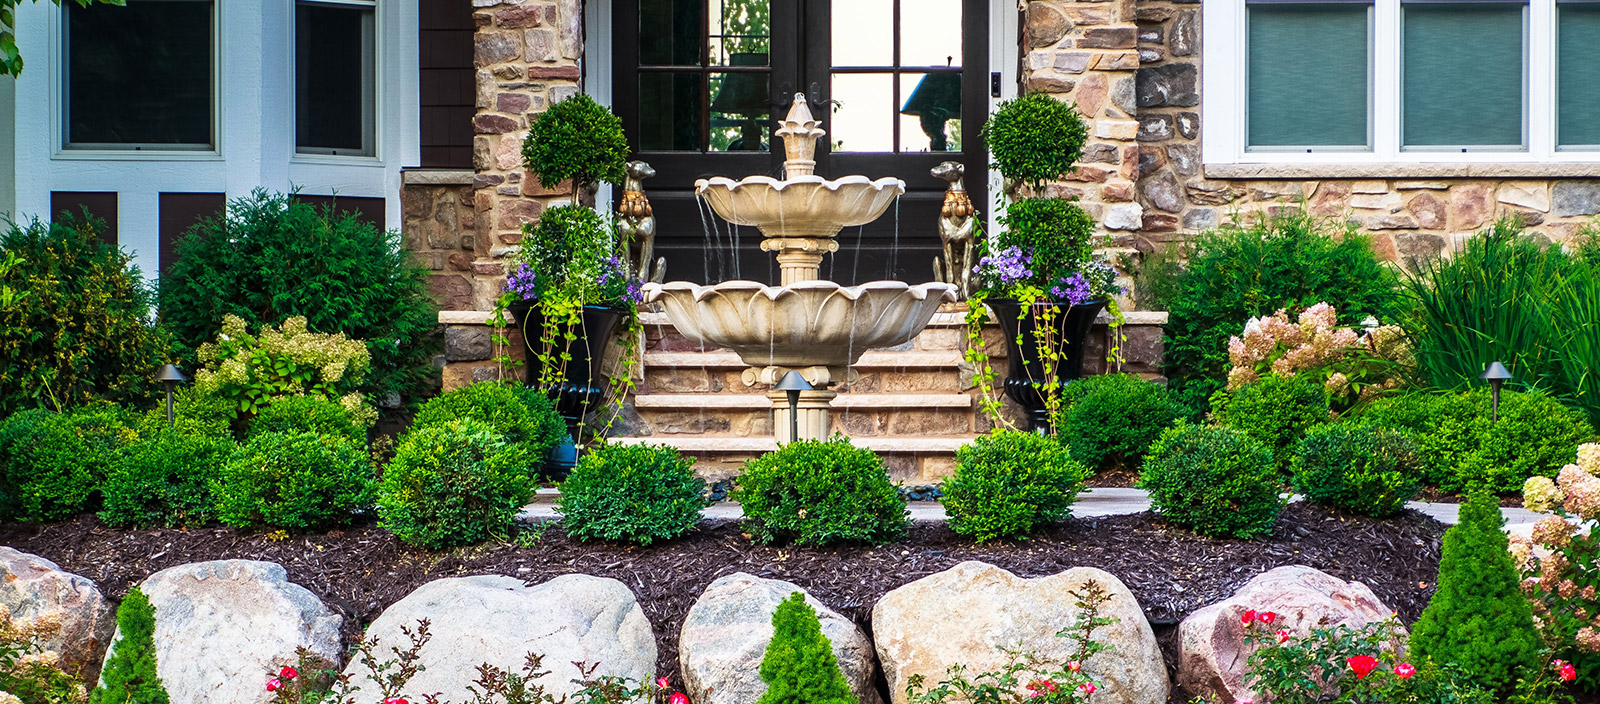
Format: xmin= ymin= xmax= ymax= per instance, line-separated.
xmin=211 ymin=432 xmax=373 ymax=531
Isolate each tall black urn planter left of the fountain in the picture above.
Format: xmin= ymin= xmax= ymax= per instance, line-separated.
xmin=509 ymin=301 xmax=627 ymax=444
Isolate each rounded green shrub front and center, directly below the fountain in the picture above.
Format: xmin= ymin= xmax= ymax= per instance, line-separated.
xmin=730 ymin=437 xmax=910 ymax=546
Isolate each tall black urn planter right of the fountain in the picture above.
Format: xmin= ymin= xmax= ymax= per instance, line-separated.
xmin=984 ymin=298 xmax=1106 ymax=430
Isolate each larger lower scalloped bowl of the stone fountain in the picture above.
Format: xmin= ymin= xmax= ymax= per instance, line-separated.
xmin=645 ymin=282 xmax=955 ymax=368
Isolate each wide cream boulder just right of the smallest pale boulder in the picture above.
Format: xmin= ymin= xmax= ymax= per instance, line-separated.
xmin=872 ymin=562 xmax=1170 ymax=704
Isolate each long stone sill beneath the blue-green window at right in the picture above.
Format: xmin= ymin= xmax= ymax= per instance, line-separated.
xmin=1205 ymin=162 xmax=1600 ymax=179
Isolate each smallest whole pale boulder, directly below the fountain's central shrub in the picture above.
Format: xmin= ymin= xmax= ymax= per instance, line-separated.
xmin=678 ymin=573 xmax=883 ymax=704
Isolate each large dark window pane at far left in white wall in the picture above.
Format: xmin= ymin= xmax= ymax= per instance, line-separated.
xmin=67 ymin=0 xmax=211 ymax=147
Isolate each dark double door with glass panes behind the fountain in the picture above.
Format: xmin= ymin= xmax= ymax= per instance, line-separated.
xmin=613 ymin=0 xmax=989 ymax=283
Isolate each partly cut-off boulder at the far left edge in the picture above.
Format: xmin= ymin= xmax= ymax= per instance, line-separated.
xmin=0 ymin=547 xmax=117 ymax=682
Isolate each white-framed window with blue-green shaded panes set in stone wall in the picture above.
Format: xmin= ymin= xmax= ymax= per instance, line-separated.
xmin=1202 ymin=0 xmax=1600 ymax=165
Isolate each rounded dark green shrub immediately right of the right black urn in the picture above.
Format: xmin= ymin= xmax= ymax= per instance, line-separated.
xmin=1056 ymin=374 xmax=1189 ymax=472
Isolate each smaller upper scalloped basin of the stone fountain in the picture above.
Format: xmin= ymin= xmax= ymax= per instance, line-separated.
xmin=694 ymin=176 xmax=906 ymax=240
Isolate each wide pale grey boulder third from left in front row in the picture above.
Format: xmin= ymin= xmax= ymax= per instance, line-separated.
xmin=344 ymin=574 xmax=656 ymax=701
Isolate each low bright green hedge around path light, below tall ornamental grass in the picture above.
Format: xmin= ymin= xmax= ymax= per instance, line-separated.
xmin=1358 ymin=389 xmax=1595 ymax=493
